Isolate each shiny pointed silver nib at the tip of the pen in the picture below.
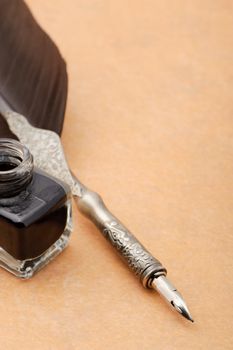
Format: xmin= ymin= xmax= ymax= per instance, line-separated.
xmin=151 ymin=276 xmax=194 ymax=322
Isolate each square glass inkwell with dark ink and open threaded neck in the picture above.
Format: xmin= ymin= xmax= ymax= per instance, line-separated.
xmin=0 ymin=138 xmax=72 ymax=278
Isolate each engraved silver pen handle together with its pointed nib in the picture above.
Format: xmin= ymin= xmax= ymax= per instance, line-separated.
xmin=74 ymin=186 xmax=193 ymax=322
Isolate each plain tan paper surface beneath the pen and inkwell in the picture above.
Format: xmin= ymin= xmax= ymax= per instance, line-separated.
xmin=0 ymin=0 xmax=233 ymax=350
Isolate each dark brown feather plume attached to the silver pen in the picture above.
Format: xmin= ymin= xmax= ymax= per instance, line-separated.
xmin=0 ymin=0 xmax=67 ymax=137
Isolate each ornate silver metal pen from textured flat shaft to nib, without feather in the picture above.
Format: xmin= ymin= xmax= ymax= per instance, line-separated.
xmin=4 ymin=112 xmax=193 ymax=322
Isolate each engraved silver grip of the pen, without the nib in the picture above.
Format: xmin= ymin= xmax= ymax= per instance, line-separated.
xmin=76 ymin=188 xmax=166 ymax=288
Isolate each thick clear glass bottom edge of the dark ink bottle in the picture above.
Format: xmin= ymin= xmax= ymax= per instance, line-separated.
xmin=0 ymin=201 xmax=72 ymax=279
